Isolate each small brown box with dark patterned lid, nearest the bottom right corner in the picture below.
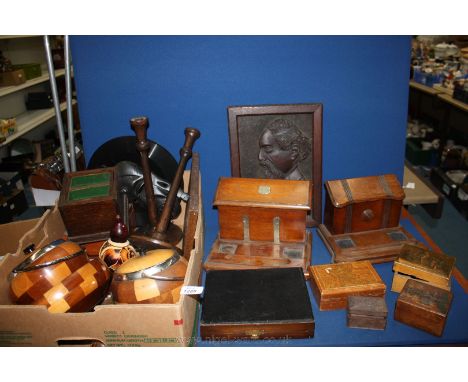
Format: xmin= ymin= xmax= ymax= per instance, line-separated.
xmin=394 ymin=279 xmax=453 ymax=336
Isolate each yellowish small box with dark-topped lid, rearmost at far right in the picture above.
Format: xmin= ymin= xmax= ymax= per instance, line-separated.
xmin=392 ymin=245 xmax=455 ymax=293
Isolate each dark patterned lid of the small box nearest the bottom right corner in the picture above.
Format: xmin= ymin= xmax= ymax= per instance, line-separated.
xmin=397 ymin=279 xmax=453 ymax=316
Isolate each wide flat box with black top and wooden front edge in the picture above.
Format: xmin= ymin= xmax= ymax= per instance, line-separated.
xmin=200 ymin=268 xmax=315 ymax=341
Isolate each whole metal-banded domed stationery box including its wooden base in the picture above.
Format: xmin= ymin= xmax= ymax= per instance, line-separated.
xmin=318 ymin=174 xmax=418 ymax=263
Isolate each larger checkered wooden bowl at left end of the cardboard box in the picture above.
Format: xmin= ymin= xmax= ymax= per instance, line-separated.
xmin=10 ymin=240 xmax=111 ymax=313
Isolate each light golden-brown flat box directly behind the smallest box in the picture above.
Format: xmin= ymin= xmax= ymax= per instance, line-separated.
xmin=309 ymin=260 xmax=386 ymax=310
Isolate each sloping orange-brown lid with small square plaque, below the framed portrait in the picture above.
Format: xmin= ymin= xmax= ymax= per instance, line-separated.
xmin=213 ymin=177 xmax=312 ymax=210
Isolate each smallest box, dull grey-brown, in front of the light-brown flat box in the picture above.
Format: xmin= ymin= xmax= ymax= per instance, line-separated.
xmin=347 ymin=296 xmax=388 ymax=330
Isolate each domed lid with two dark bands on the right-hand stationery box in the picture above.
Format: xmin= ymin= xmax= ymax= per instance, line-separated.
xmin=325 ymin=174 xmax=405 ymax=207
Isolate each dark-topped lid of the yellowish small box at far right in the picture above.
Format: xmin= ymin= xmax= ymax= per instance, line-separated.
xmin=394 ymin=244 xmax=455 ymax=279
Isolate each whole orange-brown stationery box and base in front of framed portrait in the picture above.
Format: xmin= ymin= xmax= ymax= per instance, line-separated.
xmin=204 ymin=178 xmax=312 ymax=276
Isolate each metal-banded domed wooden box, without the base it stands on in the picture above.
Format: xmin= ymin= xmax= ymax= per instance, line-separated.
xmin=324 ymin=174 xmax=405 ymax=235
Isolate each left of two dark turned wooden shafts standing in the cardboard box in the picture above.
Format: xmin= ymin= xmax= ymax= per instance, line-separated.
xmin=130 ymin=117 xmax=157 ymax=227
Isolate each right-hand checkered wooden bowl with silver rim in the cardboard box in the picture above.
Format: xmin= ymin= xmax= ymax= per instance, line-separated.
xmin=111 ymin=249 xmax=187 ymax=304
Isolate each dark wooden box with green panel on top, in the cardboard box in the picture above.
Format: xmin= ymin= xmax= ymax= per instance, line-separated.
xmin=58 ymin=167 xmax=118 ymax=243
